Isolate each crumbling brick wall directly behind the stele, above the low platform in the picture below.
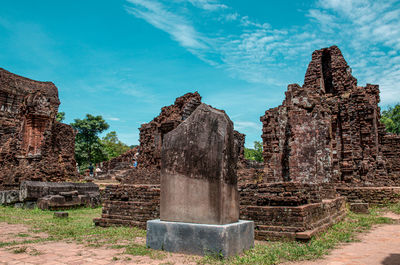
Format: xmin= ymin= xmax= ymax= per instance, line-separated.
xmin=100 ymin=92 xmax=245 ymax=184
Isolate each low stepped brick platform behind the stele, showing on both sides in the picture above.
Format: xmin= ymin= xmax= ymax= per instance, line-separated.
xmin=94 ymin=184 xmax=345 ymax=240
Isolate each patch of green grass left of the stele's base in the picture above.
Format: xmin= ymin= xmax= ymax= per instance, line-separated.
xmin=0 ymin=206 xmax=166 ymax=259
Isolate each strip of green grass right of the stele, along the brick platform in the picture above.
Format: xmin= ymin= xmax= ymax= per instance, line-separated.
xmin=199 ymin=209 xmax=392 ymax=265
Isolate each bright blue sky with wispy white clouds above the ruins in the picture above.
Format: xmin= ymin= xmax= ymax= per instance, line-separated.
xmin=0 ymin=0 xmax=400 ymax=147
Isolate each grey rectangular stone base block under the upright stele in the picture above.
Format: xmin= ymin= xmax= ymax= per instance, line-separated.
xmin=146 ymin=219 xmax=254 ymax=257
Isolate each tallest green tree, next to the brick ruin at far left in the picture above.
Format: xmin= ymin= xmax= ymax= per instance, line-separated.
xmin=71 ymin=114 xmax=109 ymax=166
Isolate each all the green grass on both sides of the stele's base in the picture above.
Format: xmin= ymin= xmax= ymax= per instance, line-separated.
xmin=0 ymin=203 xmax=400 ymax=264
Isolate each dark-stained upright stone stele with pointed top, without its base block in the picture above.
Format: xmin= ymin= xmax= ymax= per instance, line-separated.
xmin=160 ymin=104 xmax=239 ymax=225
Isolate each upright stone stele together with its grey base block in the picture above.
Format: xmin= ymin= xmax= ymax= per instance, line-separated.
xmin=146 ymin=104 xmax=254 ymax=256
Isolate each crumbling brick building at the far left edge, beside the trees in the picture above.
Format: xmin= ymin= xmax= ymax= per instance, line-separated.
xmin=0 ymin=68 xmax=77 ymax=190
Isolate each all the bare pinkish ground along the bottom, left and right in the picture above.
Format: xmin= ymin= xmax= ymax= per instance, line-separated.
xmin=0 ymin=213 xmax=400 ymax=265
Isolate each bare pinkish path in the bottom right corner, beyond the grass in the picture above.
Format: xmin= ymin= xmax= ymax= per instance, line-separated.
xmin=287 ymin=213 xmax=400 ymax=265
